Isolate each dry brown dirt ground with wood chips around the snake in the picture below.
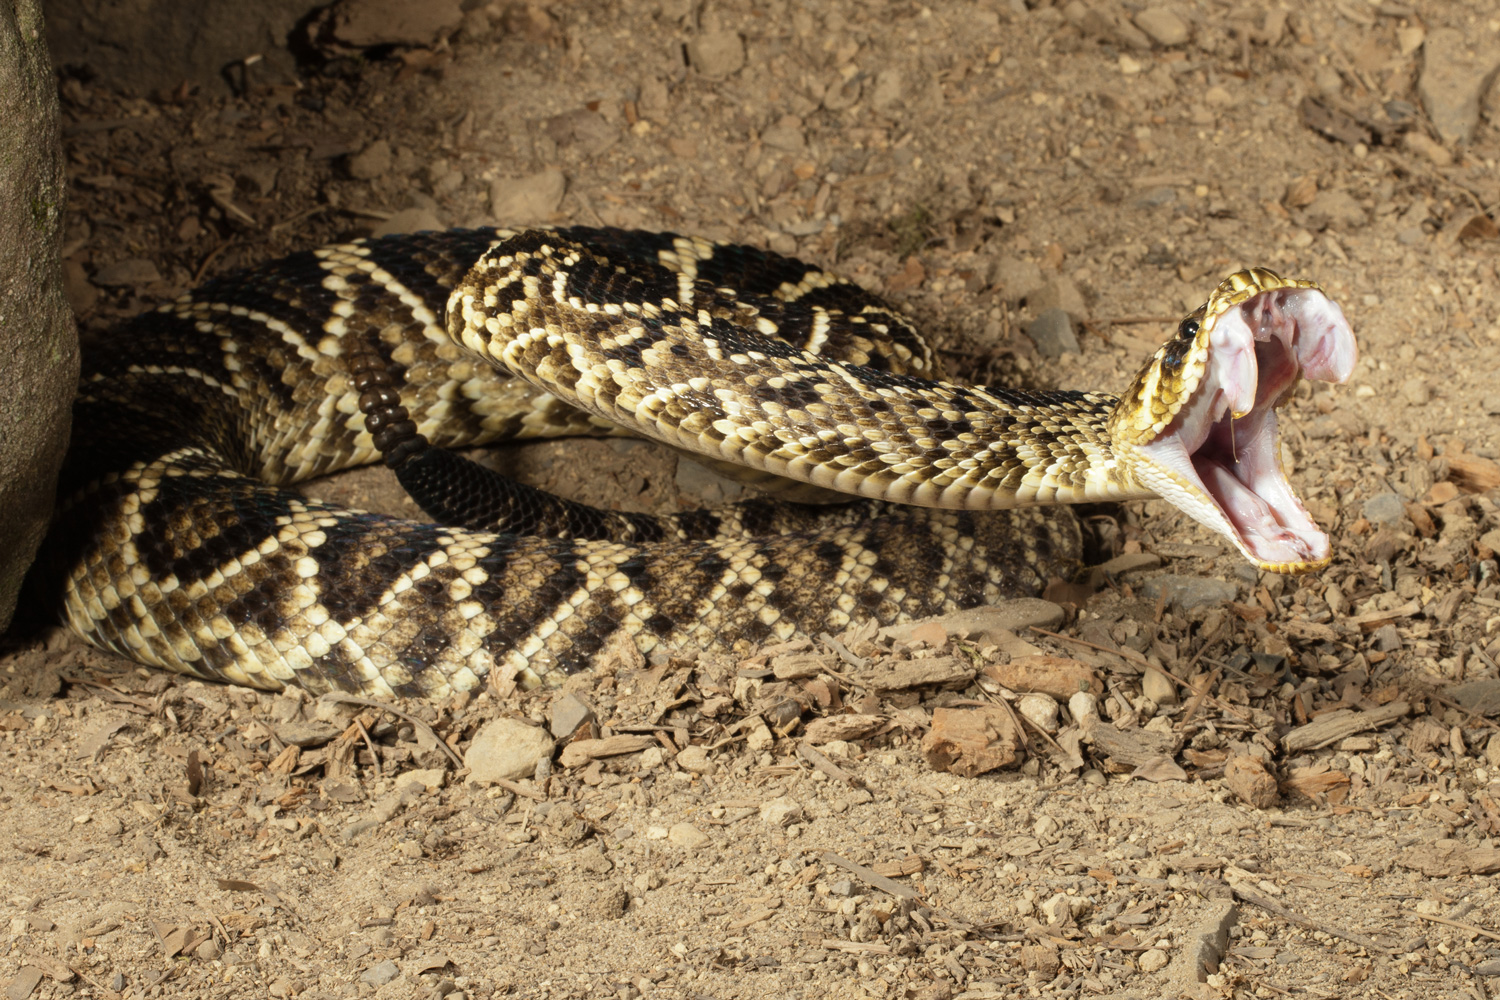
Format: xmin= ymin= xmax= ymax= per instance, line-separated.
xmin=0 ymin=0 xmax=1500 ymax=1000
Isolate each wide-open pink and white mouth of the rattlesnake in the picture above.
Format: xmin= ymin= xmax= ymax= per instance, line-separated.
xmin=1139 ymin=288 xmax=1356 ymax=573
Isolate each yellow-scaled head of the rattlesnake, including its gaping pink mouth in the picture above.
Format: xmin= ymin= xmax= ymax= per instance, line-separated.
xmin=1110 ymin=268 xmax=1356 ymax=573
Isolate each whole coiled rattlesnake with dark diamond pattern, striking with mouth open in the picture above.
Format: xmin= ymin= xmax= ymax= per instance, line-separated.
xmin=33 ymin=228 xmax=1355 ymax=697
